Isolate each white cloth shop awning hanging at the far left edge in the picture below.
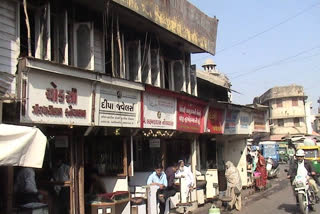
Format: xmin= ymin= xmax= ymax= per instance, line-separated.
xmin=0 ymin=124 xmax=47 ymax=168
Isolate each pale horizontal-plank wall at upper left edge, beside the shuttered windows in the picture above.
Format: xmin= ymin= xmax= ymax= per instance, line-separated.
xmin=0 ymin=0 xmax=20 ymax=96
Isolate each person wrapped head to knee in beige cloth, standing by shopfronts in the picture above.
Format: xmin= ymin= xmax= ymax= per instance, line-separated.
xmin=225 ymin=161 xmax=242 ymax=211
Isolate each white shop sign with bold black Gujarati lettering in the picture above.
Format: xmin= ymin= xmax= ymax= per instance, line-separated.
xmin=98 ymin=85 xmax=141 ymax=128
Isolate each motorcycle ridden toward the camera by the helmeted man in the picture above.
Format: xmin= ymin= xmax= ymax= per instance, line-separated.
xmin=292 ymin=175 xmax=316 ymax=214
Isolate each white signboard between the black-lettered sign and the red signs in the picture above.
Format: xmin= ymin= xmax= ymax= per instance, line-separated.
xmin=142 ymin=92 xmax=177 ymax=130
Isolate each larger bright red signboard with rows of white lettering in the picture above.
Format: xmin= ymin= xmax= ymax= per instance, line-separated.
xmin=177 ymin=99 xmax=205 ymax=133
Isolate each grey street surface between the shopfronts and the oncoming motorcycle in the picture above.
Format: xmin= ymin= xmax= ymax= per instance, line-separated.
xmin=232 ymin=165 xmax=320 ymax=214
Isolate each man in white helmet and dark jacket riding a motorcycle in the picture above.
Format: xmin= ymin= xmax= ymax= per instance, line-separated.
xmin=288 ymin=149 xmax=319 ymax=201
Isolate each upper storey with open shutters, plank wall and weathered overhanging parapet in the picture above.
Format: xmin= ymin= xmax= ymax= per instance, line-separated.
xmin=0 ymin=0 xmax=218 ymax=101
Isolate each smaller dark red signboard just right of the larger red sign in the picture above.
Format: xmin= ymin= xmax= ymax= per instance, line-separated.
xmin=207 ymin=108 xmax=224 ymax=134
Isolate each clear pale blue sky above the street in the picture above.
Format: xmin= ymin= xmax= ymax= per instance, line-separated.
xmin=189 ymin=0 xmax=320 ymax=113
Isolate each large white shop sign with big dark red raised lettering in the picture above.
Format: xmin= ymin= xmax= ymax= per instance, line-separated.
xmin=21 ymin=70 xmax=92 ymax=125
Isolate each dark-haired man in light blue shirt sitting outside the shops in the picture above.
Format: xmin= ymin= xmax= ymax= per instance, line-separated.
xmin=147 ymin=165 xmax=168 ymax=214
